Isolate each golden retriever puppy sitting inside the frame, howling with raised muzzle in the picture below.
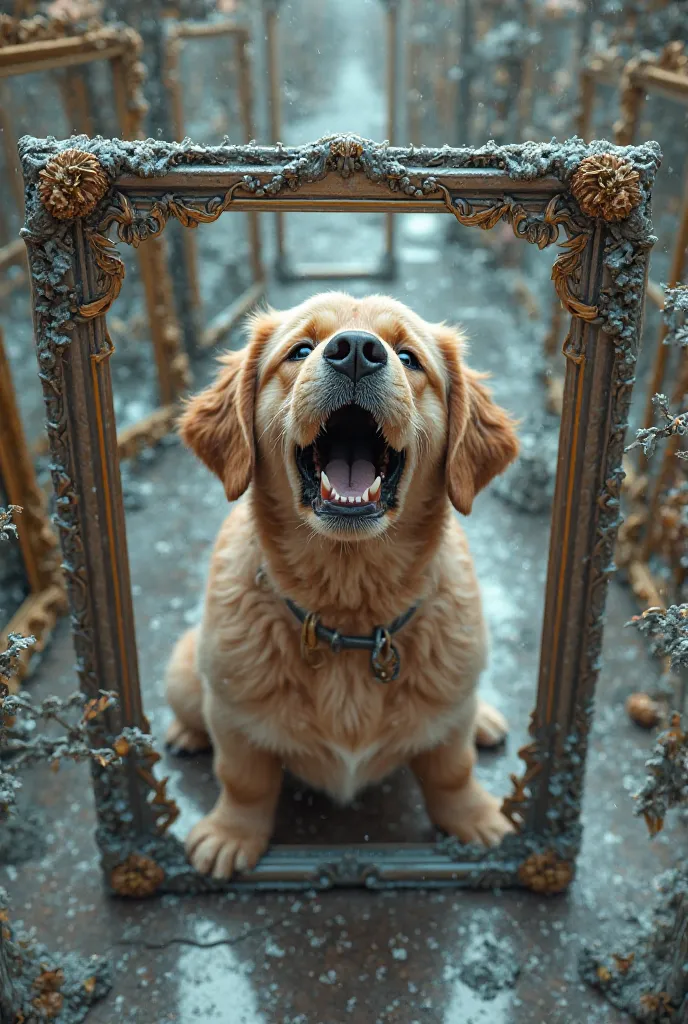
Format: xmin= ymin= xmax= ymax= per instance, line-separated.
xmin=167 ymin=293 xmax=518 ymax=879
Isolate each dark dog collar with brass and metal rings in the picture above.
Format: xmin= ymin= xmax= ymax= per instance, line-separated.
xmin=256 ymin=568 xmax=419 ymax=683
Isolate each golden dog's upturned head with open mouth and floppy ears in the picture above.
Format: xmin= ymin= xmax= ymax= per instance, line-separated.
xmin=181 ymin=293 xmax=518 ymax=540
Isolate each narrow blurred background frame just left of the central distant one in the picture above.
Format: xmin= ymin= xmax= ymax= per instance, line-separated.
xmin=165 ymin=18 xmax=265 ymax=349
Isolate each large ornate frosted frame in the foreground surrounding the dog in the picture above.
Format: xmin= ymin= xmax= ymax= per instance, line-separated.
xmin=19 ymin=135 xmax=659 ymax=896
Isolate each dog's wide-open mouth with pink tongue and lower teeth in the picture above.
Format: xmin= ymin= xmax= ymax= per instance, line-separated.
xmin=296 ymin=406 xmax=404 ymax=519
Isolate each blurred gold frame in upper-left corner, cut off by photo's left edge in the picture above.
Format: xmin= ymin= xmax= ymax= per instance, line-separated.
xmin=0 ymin=17 xmax=190 ymax=459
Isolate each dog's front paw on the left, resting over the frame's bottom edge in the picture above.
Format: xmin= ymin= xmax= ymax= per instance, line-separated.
xmin=186 ymin=814 xmax=269 ymax=879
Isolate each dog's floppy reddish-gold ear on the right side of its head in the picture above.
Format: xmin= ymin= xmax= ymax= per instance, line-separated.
xmin=437 ymin=327 xmax=518 ymax=515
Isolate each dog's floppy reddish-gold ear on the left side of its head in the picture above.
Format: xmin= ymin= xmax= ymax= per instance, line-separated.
xmin=179 ymin=311 xmax=280 ymax=502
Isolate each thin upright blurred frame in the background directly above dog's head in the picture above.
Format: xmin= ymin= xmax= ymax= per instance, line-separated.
xmin=262 ymin=0 xmax=402 ymax=282
